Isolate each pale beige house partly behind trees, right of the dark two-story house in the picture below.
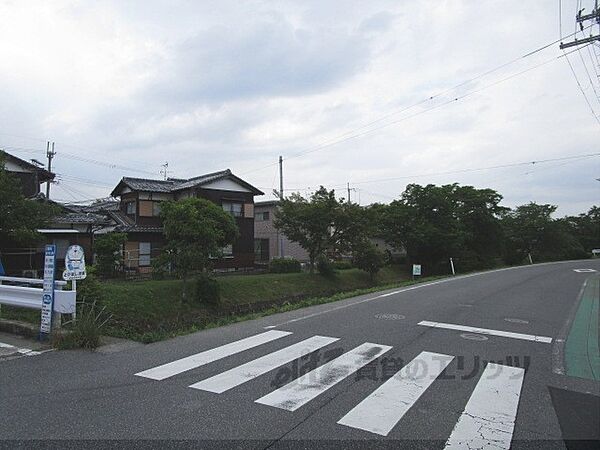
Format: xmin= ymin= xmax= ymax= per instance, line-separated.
xmin=254 ymin=200 xmax=309 ymax=263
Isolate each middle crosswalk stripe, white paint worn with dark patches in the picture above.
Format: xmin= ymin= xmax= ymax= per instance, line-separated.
xmin=255 ymin=342 xmax=392 ymax=411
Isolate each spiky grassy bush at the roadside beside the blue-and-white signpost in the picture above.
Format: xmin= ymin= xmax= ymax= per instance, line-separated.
xmin=53 ymin=302 xmax=110 ymax=350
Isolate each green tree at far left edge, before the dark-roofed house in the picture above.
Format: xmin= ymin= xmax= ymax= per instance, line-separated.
xmin=0 ymin=153 xmax=58 ymax=246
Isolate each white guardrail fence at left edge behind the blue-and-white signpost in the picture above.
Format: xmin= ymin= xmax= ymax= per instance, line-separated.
xmin=0 ymin=276 xmax=77 ymax=314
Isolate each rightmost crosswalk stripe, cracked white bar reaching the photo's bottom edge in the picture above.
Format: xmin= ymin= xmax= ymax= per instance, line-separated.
xmin=445 ymin=363 xmax=525 ymax=449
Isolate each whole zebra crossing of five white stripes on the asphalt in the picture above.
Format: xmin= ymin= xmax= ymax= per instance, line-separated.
xmin=135 ymin=330 xmax=525 ymax=449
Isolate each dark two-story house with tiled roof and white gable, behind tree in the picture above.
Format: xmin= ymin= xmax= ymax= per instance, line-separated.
xmin=110 ymin=169 xmax=263 ymax=273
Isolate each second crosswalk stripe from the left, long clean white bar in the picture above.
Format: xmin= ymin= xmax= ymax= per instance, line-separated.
xmin=190 ymin=336 xmax=339 ymax=394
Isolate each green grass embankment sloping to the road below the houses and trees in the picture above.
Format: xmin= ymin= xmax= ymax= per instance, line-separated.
xmin=2 ymin=266 xmax=442 ymax=342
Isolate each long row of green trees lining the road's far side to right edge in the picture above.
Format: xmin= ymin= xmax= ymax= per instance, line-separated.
xmin=275 ymin=183 xmax=600 ymax=274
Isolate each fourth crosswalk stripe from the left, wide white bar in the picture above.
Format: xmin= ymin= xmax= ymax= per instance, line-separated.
xmin=338 ymin=352 xmax=454 ymax=436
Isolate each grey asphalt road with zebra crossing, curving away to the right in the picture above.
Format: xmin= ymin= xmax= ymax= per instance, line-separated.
xmin=0 ymin=260 xmax=600 ymax=448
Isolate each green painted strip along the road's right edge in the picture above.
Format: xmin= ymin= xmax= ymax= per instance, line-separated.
xmin=565 ymin=276 xmax=600 ymax=381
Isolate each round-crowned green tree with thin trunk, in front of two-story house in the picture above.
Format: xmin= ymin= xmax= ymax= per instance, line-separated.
xmin=160 ymin=198 xmax=239 ymax=300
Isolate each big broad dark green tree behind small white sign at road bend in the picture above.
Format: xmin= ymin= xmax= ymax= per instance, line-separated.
xmin=380 ymin=184 xmax=506 ymax=272
